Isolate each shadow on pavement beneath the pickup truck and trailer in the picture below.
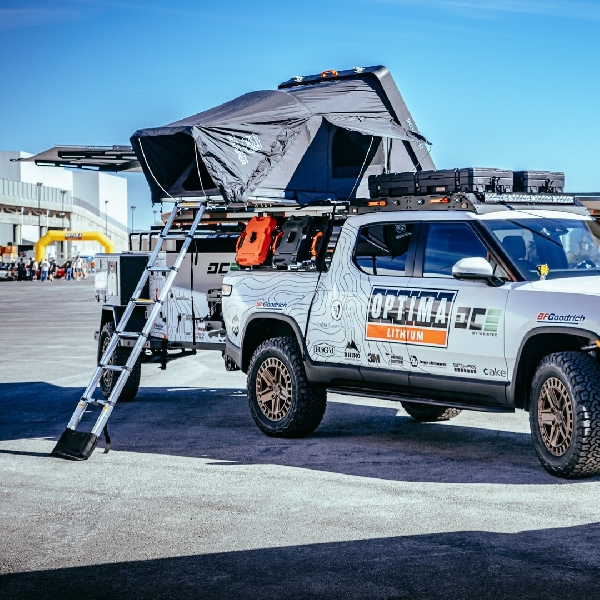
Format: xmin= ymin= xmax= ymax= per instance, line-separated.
xmin=0 ymin=382 xmax=597 ymax=485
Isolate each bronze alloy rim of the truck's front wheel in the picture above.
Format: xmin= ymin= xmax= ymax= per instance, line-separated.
xmin=538 ymin=377 xmax=573 ymax=456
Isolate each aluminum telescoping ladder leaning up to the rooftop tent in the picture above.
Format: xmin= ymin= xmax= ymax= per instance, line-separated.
xmin=52 ymin=201 xmax=206 ymax=460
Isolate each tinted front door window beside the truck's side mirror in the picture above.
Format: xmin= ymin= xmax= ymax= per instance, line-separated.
xmin=423 ymin=223 xmax=487 ymax=277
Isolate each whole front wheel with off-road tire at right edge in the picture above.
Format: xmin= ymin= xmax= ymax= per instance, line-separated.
xmin=529 ymin=352 xmax=600 ymax=478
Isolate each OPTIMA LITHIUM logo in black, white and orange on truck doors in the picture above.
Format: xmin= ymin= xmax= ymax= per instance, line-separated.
xmin=366 ymin=287 xmax=456 ymax=348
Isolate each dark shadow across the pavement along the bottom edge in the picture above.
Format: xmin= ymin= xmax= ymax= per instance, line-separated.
xmin=0 ymin=523 xmax=600 ymax=600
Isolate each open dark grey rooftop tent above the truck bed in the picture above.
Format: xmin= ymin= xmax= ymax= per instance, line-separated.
xmin=131 ymin=67 xmax=434 ymax=204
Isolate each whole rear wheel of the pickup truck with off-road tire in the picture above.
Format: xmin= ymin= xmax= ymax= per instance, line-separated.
xmin=247 ymin=337 xmax=327 ymax=438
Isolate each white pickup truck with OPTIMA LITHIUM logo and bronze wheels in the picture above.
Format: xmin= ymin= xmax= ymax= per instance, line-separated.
xmin=223 ymin=194 xmax=600 ymax=477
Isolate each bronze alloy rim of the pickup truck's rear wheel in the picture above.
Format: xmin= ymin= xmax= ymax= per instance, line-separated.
xmin=256 ymin=356 xmax=292 ymax=421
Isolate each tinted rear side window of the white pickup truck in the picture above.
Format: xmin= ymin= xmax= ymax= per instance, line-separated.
xmin=355 ymin=223 xmax=414 ymax=277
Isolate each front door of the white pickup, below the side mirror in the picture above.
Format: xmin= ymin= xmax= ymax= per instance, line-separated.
xmin=406 ymin=222 xmax=511 ymax=404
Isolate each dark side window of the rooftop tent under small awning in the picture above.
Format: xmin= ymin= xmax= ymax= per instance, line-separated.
xmin=331 ymin=128 xmax=383 ymax=178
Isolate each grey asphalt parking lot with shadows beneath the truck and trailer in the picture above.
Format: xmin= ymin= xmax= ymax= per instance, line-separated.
xmin=0 ymin=279 xmax=600 ymax=599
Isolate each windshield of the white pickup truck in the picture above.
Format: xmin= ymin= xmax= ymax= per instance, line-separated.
xmin=482 ymin=218 xmax=600 ymax=281
